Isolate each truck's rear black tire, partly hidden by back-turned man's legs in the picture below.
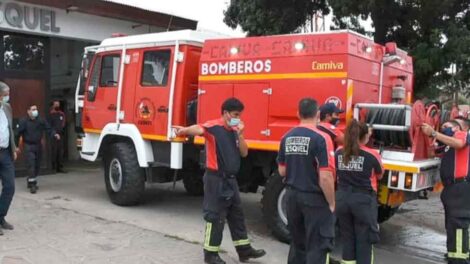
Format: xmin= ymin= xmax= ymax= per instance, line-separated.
xmin=261 ymin=172 xmax=291 ymax=243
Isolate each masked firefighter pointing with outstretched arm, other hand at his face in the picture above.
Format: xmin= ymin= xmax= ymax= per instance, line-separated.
xmin=174 ymin=98 xmax=266 ymax=264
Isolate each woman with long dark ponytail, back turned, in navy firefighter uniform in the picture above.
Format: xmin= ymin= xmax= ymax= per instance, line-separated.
xmin=335 ymin=120 xmax=384 ymax=264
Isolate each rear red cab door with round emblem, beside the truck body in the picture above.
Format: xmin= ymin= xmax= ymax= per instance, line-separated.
xmin=134 ymin=47 xmax=173 ymax=140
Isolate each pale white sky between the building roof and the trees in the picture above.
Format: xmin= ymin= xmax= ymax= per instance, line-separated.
xmin=107 ymin=0 xmax=244 ymax=36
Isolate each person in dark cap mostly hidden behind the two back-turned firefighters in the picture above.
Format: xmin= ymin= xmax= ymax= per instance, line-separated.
xmin=318 ymin=103 xmax=344 ymax=150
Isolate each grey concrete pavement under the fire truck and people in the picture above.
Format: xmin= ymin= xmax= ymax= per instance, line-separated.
xmin=0 ymin=162 xmax=445 ymax=264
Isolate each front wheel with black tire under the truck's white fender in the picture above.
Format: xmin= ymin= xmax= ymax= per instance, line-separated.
xmin=103 ymin=142 xmax=145 ymax=206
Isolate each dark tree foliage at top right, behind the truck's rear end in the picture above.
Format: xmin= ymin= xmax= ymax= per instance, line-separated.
xmin=329 ymin=0 xmax=470 ymax=98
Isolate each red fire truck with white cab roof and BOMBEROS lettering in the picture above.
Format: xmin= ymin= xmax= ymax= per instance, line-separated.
xmin=76 ymin=31 xmax=439 ymax=240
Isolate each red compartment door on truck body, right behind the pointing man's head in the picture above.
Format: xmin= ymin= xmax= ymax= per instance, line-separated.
xmin=234 ymin=83 xmax=272 ymax=140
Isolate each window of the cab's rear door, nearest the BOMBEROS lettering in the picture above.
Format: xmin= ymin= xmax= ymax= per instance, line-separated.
xmin=141 ymin=50 xmax=171 ymax=87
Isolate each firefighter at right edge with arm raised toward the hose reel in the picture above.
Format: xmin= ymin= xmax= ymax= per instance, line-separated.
xmin=422 ymin=120 xmax=470 ymax=264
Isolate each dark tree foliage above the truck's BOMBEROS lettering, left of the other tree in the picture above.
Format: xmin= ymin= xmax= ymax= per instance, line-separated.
xmin=224 ymin=0 xmax=329 ymax=36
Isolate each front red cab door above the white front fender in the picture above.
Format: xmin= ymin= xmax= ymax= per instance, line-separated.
xmin=83 ymin=53 xmax=121 ymax=129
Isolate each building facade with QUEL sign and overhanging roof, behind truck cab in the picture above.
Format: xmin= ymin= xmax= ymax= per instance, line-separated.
xmin=0 ymin=0 xmax=197 ymax=174
